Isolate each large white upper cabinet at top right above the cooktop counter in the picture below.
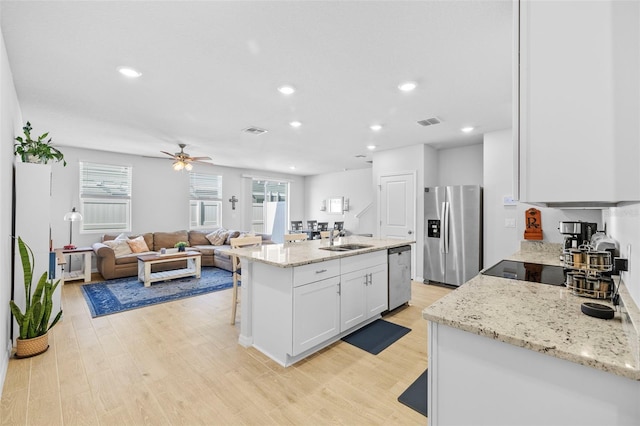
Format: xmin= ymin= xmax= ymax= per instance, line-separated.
xmin=514 ymin=1 xmax=640 ymax=203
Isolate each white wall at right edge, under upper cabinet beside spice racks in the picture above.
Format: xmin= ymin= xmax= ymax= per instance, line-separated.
xmin=603 ymin=203 xmax=640 ymax=306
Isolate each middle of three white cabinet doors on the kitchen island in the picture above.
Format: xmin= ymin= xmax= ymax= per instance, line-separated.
xmin=340 ymin=271 xmax=368 ymax=331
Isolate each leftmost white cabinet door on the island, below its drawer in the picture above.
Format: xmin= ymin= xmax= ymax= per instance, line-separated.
xmin=292 ymin=277 xmax=340 ymax=355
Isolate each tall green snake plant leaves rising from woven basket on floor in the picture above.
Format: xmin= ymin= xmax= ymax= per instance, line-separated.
xmin=9 ymin=237 xmax=62 ymax=339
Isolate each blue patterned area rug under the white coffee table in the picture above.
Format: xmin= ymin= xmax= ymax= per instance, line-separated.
xmin=81 ymin=267 xmax=233 ymax=318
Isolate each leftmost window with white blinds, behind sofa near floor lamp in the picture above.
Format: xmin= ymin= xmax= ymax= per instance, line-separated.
xmin=80 ymin=161 xmax=132 ymax=232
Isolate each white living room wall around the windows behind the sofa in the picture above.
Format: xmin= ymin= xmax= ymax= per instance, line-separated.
xmin=51 ymin=148 xmax=305 ymax=251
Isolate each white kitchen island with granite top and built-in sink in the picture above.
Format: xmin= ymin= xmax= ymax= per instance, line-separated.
xmin=222 ymin=236 xmax=413 ymax=366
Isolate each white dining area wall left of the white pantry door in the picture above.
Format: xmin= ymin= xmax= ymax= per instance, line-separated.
xmin=304 ymin=168 xmax=376 ymax=234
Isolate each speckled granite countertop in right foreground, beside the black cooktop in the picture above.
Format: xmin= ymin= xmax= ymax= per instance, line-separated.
xmin=422 ymin=243 xmax=640 ymax=380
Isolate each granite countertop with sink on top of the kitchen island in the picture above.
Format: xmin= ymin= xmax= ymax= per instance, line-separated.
xmin=224 ymin=236 xmax=415 ymax=268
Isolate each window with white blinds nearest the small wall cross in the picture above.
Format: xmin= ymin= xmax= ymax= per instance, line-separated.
xmin=189 ymin=173 xmax=222 ymax=229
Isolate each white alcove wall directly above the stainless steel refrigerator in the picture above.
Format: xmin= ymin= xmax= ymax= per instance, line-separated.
xmin=438 ymin=143 xmax=483 ymax=186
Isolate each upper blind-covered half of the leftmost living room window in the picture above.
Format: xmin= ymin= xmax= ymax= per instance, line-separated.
xmin=80 ymin=162 xmax=131 ymax=199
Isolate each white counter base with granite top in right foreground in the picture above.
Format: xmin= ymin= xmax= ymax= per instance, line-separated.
xmin=423 ymin=244 xmax=640 ymax=425
